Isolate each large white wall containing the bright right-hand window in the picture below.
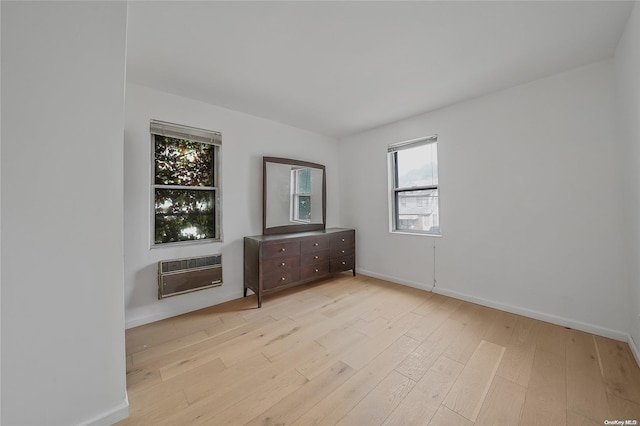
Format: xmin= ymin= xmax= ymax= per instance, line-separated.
xmin=340 ymin=61 xmax=628 ymax=340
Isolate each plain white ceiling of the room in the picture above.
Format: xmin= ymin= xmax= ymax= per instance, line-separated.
xmin=127 ymin=1 xmax=632 ymax=137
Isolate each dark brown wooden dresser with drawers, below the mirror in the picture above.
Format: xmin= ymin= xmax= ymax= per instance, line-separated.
xmin=244 ymin=228 xmax=356 ymax=307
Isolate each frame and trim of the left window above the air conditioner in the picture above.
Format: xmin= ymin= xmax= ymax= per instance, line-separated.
xmin=149 ymin=119 xmax=223 ymax=249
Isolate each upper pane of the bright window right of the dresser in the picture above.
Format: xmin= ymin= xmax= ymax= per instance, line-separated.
xmin=396 ymin=142 xmax=438 ymax=188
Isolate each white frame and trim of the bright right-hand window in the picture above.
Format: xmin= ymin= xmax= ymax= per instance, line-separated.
xmin=387 ymin=135 xmax=442 ymax=237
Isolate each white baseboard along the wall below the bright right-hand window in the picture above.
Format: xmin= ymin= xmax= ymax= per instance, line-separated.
xmin=358 ymin=270 xmax=628 ymax=342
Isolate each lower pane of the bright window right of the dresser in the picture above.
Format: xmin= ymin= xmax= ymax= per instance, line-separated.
xmin=396 ymin=189 xmax=440 ymax=233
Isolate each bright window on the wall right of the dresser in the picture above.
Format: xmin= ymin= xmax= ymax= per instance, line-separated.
xmin=388 ymin=136 xmax=440 ymax=235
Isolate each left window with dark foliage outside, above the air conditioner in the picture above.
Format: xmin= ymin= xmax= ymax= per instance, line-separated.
xmin=150 ymin=120 xmax=222 ymax=246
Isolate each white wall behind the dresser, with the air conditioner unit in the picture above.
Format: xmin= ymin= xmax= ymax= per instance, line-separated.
xmin=124 ymin=84 xmax=340 ymax=327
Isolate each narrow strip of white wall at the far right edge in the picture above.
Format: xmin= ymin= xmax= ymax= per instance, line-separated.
xmin=615 ymin=2 xmax=640 ymax=354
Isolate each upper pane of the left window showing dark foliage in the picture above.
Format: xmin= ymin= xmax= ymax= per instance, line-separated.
xmin=154 ymin=135 xmax=215 ymax=186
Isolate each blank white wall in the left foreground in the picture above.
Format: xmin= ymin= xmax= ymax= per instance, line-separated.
xmin=1 ymin=2 xmax=128 ymax=426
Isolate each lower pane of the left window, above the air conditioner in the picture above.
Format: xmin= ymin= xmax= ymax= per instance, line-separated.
xmin=155 ymin=189 xmax=215 ymax=244
